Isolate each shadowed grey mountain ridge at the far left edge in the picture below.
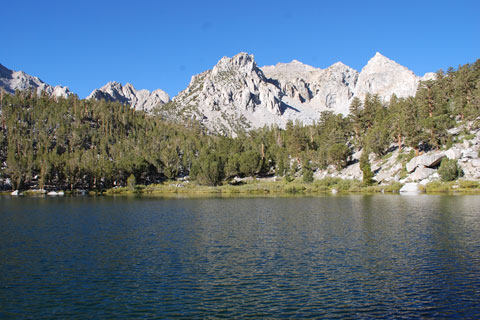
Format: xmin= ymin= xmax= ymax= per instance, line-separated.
xmin=0 ymin=64 xmax=71 ymax=97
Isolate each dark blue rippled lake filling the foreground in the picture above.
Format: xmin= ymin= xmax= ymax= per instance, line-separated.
xmin=0 ymin=195 xmax=480 ymax=319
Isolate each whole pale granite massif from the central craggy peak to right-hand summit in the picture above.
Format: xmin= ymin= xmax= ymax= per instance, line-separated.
xmin=169 ymin=53 xmax=434 ymax=134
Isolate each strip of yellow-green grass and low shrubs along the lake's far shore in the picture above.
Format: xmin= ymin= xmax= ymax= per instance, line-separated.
xmin=0 ymin=178 xmax=480 ymax=197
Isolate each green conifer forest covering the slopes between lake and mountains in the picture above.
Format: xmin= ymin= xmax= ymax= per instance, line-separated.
xmin=0 ymin=60 xmax=480 ymax=190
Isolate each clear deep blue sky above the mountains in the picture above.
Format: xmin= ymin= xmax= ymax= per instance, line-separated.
xmin=0 ymin=0 xmax=480 ymax=98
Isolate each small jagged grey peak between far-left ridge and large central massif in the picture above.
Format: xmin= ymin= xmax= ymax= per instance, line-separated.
xmin=87 ymin=81 xmax=170 ymax=111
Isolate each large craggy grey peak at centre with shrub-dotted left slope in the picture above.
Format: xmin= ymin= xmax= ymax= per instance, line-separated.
xmin=173 ymin=53 xmax=287 ymax=134
